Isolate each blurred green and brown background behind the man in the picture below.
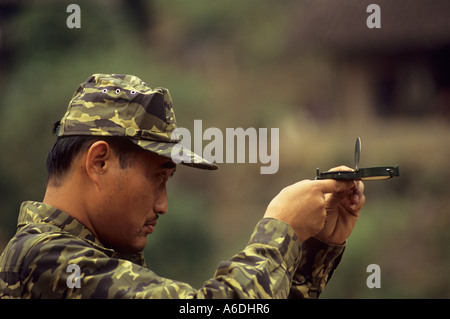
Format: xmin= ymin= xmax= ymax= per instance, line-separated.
xmin=0 ymin=0 xmax=450 ymax=298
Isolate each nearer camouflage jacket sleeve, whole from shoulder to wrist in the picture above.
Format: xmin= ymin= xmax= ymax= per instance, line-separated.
xmin=9 ymin=219 xmax=301 ymax=298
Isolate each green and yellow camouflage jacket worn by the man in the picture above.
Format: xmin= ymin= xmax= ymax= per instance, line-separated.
xmin=0 ymin=202 xmax=344 ymax=299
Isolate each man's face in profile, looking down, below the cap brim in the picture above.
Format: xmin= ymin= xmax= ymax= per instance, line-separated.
xmin=95 ymin=151 xmax=175 ymax=253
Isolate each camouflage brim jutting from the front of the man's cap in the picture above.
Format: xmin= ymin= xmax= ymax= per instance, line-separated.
xmin=131 ymin=138 xmax=219 ymax=170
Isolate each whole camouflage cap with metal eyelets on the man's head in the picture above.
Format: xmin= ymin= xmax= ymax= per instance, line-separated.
xmin=56 ymin=74 xmax=218 ymax=169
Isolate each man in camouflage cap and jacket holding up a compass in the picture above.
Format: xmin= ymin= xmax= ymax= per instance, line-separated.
xmin=0 ymin=74 xmax=365 ymax=298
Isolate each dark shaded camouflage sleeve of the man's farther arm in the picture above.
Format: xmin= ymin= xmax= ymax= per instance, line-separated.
xmin=289 ymin=237 xmax=345 ymax=299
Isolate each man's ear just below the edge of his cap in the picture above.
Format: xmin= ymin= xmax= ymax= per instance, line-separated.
xmin=85 ymin=141 xmax=113 ymax=184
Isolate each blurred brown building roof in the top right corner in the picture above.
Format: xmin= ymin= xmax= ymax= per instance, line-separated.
xmin=292 ymin=0 xmax=450 ymax=54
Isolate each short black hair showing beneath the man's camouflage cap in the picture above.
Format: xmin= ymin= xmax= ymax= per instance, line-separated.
xmin=46 ymin=135 xmax=140 ymax=186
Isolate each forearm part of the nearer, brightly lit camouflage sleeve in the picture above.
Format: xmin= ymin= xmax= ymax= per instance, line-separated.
xmin=200 ymin=218 xmax=301 ymax=298
